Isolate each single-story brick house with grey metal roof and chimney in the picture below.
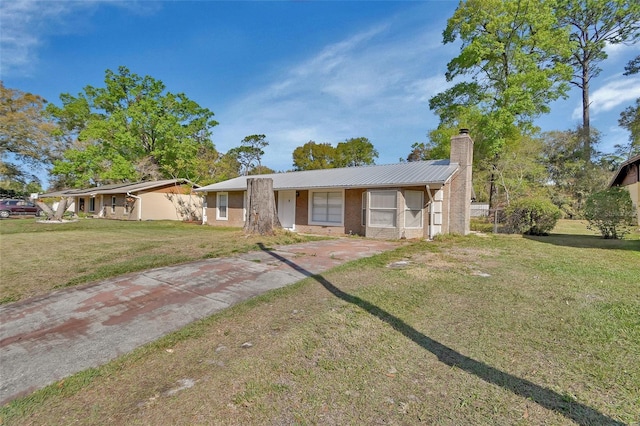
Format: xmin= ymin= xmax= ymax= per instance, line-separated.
xmin=196 ymin=129 xmax=473 ymax=239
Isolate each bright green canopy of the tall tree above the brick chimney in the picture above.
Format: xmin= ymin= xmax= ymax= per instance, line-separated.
xmin=429 ymin=0 xmax=571 ymax=156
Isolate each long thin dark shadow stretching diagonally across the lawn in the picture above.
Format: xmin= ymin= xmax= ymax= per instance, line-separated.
xmin=258 ymin=244 xmax=624 ymax=425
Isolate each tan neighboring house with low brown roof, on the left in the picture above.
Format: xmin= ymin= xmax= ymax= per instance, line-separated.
xmin=39 ymin=179 xmax=202 ymax=220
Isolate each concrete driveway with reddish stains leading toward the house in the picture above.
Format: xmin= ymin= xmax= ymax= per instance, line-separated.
xmin=0 ymin=238 xmax=399 ymax=405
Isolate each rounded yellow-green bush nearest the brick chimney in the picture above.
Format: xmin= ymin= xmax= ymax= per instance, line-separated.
xmin=505 ymin=198 xmax=562 ymax=235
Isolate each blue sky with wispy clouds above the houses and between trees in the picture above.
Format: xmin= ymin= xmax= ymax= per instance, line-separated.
xmin=0 ymin=0 xmax=640 ymax=184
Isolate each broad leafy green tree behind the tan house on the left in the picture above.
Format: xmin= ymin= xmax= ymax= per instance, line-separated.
xmin=48 ymin=67 xmax=218 ymax=186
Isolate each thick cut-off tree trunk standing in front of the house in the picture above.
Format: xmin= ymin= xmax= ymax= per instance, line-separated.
xmin=244 ymin=178 xmax=282 ymax=235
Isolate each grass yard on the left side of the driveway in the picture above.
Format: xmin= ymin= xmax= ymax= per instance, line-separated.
xmin=0 ymin=218 xmax=320 ymax=304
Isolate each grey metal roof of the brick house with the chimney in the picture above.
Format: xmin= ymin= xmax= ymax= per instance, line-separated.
xmin=196 ymin=160 xmax=458 ymax=192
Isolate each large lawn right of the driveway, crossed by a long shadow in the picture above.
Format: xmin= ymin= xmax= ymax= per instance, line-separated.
xmin=0 ymin=222 xmax=640 ymax=425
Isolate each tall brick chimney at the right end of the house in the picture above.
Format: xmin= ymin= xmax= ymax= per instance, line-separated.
xmin=449 ymin=129 xmax=473 ymax=235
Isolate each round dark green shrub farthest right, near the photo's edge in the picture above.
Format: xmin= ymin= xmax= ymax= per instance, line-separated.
xmin=584 ymin=186 xmax=635 ymax=239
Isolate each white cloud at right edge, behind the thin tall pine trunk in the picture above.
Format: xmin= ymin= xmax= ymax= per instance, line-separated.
xmin=571 ymin=74 xmax=640 ymax=120
